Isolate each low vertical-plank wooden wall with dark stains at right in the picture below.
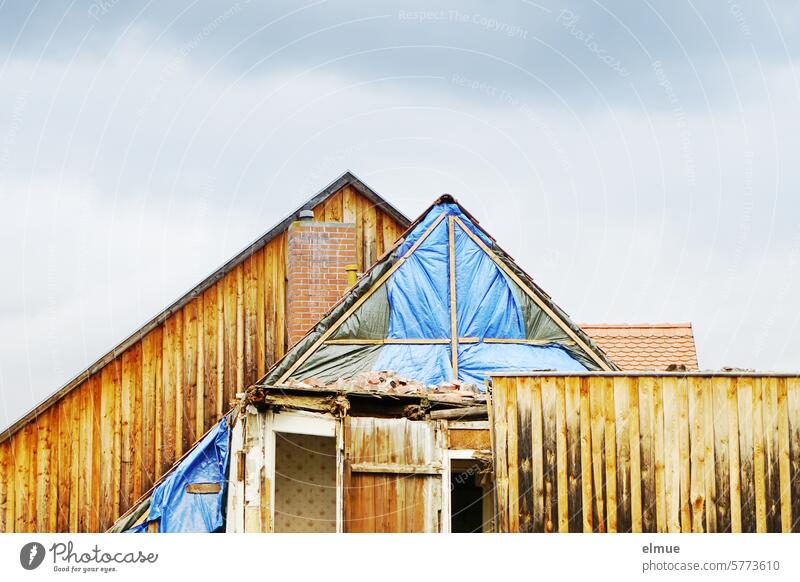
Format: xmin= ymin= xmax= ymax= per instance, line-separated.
xmin=490 ymin=375 xmax=800 ymax=532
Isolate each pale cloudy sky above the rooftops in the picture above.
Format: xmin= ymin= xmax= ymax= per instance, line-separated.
xmin=0 ymin=0 xmax=800 ymax=434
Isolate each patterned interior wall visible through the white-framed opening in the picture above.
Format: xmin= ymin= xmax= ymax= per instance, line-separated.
xmin=275 ymin=433 xmax=336 ymax=533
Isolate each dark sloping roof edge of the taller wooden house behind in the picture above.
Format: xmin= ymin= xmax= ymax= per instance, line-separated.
xmin=0 ymin=170 xmax=411 ymax=443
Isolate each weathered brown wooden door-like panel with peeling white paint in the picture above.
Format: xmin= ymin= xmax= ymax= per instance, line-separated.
xmin=344 ymin=417 xmax=445 ymax=533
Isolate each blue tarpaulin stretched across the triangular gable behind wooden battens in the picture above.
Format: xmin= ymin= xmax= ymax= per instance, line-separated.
xmin=372 ymin=203 xmax=586 ymax=387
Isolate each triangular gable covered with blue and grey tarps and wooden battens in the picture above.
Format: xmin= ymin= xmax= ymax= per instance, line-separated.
xmin=261 ymin=196 xmax=614 ymax=385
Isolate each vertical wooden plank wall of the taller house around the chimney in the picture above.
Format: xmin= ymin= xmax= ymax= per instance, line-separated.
xmin=0 ymin=185 xmax=404 ymax=532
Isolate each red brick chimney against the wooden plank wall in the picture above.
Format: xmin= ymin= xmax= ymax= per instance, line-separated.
xmin=286 ymin=217 xmax=357 ymax=346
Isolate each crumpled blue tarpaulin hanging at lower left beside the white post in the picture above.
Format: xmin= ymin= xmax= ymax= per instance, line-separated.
xmin=127 ymin=418 xmax=229 ymax=533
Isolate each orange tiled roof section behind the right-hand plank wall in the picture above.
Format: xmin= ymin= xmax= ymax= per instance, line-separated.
xmin=580 ymin=323 xmax=699 ymax=371
